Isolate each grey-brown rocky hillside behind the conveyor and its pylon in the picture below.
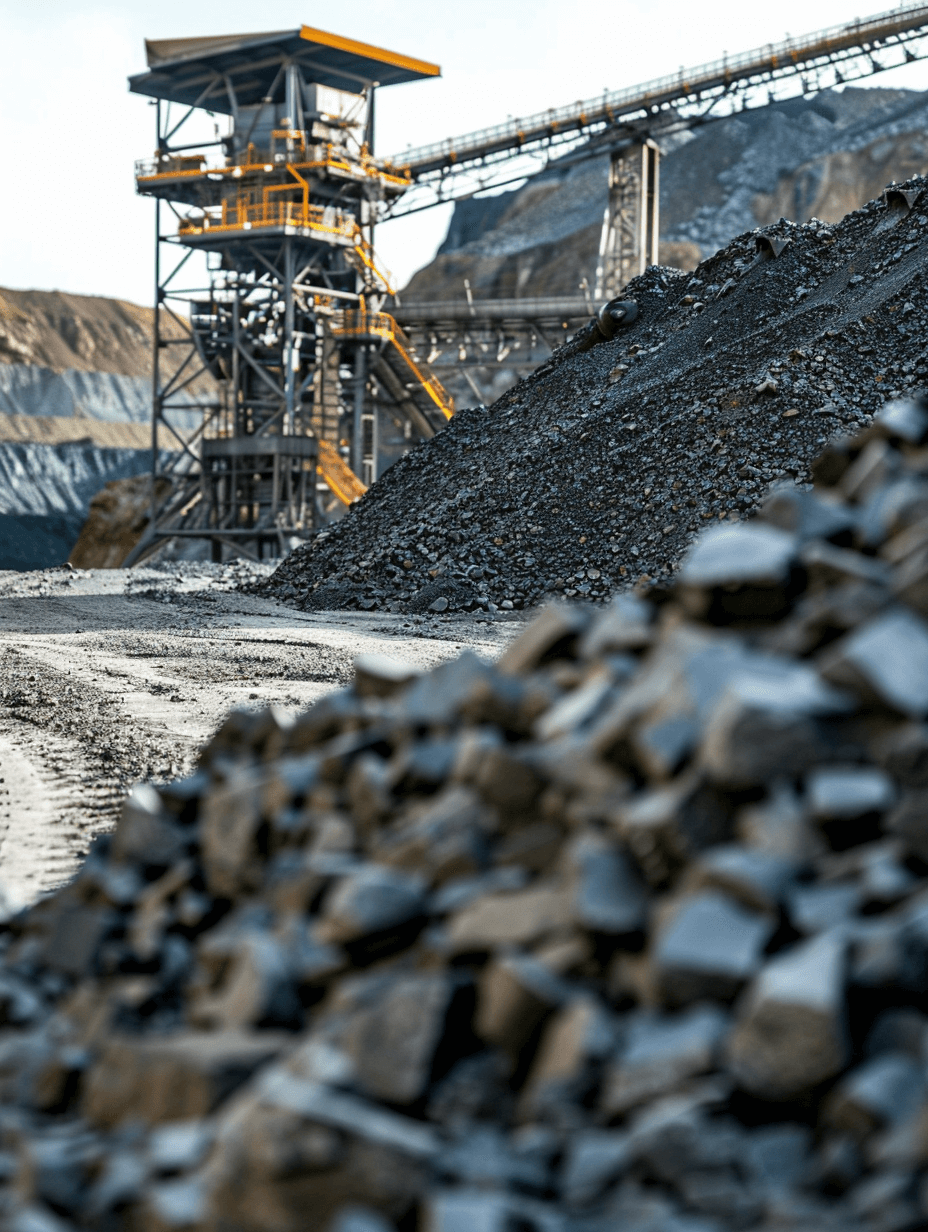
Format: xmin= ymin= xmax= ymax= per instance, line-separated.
xmin=404 ymin=89 xmax=928 ymax=301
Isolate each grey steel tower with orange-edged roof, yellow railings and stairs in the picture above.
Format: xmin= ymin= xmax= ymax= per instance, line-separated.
xmin=129 ymin=26 xmax=454 ymax=559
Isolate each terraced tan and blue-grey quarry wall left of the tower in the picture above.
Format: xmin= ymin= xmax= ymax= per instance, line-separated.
xmin=0 ymin=290 xmax=203 ymax=569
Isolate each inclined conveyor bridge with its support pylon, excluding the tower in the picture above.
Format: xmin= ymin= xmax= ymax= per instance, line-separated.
xmin=385 ymin=2 xmax=928 ymax=301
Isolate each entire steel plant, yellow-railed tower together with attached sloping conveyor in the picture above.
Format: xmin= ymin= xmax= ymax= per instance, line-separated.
xmin=129 ymin=4 xmax=928 ymax=559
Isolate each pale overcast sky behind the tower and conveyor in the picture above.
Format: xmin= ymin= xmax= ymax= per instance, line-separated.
xmin=0 ymin=0 xmax=928 ymax=303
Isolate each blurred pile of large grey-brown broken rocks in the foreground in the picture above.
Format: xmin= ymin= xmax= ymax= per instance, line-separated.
xmin=10 ymin=400 xmax=928 ymax=1232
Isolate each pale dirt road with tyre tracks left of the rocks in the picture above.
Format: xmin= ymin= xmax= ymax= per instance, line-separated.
xmin=0 ymin=565 xmax=519 ymax=909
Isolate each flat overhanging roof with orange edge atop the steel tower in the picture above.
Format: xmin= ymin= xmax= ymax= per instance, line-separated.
xmin=129 ymin=26 xmax=441 ymax=115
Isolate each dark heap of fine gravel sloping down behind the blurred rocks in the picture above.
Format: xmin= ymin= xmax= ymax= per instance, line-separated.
xmin=269 ymin=179 xmax=928 ymax=611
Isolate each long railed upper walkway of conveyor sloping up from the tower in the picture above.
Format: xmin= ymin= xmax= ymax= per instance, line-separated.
xmin=391 ymin=4 xmax=928 ymax=179
